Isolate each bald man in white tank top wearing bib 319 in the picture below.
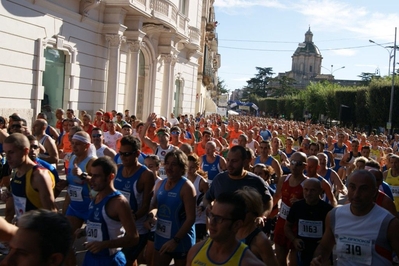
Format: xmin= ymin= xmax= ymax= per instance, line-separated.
xmin=311 ymin=170 xmax=399 ymax=266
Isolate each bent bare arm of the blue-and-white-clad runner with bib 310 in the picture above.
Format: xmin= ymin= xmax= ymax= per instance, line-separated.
xmin=86 ymin=196 xmax=139 ymax=253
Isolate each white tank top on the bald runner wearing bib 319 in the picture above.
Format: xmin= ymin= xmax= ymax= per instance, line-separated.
xmin=330 ymin=204 xmax=394 ymax=266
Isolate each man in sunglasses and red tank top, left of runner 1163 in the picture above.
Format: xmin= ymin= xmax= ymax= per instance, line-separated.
xmin=273 ymin=152 xmax=307 ymax=266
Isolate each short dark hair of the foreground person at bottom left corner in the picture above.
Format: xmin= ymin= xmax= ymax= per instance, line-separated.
xmin=18 ymin=209 xmax=72 ymax=260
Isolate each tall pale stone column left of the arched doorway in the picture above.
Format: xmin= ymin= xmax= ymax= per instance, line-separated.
xmin=105 ymin=34 xmax=123 ymax=111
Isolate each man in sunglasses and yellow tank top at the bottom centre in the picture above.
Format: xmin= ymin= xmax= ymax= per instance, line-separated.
xmin=187 ymin=192 xmax=264 ymax=265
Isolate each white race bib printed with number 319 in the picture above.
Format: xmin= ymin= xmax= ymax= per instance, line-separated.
xmin=336 ymin=236 xmax=373 ymax=265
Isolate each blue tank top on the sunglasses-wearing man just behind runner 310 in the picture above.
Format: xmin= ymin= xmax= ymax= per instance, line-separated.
xmin=114 ymin=165 xmax=147 ymax=212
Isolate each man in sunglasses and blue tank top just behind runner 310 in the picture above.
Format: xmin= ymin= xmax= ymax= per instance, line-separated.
xmin=114 ymin=135 xmax=155 ymax=265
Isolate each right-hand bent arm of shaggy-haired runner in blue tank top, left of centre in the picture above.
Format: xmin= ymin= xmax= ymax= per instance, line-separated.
xmin=159 ymin=182 xmax=196 ymax=254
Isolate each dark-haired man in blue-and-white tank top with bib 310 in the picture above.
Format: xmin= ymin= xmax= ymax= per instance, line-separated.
xmin=81 ymin=157 xmax=138 ymax=266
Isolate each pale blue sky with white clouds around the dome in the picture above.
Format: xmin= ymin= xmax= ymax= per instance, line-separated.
xmin=214 ymin=0 xmax=399 ymax=91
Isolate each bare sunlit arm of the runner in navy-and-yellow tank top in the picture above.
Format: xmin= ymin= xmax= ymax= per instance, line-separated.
xmin=32 ymin=169 xmax=57 ymax=212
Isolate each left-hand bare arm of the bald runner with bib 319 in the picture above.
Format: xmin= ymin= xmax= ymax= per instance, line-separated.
xmin=310 ymin=212 xmax=335 ymax=266
